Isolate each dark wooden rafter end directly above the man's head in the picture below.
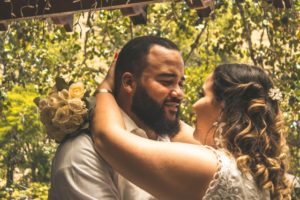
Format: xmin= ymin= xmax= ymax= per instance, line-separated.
xmin=121 ymin=5 xmax=147 ymax=25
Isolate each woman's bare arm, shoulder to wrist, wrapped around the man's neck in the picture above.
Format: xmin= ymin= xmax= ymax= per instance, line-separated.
xmin=93 ymin=84 xmax=217 ymax=199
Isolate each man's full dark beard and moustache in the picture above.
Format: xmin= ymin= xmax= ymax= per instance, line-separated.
xmin=131 ymin=86 xmax=180 ymax=136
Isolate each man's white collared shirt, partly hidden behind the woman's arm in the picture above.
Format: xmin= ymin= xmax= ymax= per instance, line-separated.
xmin=48 ymin=112 xmax=170 ymax=200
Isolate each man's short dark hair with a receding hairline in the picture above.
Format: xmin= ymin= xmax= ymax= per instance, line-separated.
xmin=115 ymin=36 xmax=179 ymax=94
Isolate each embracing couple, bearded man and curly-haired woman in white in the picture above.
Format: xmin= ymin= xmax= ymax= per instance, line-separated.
xmin=49 ymin=36 xmax=290 ymax=200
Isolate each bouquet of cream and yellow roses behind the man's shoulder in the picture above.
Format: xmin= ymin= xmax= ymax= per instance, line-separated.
xmin=34 ymin=77 xmax=95 ymax=143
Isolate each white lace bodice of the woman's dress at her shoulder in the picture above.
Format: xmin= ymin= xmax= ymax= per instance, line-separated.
xmin=203 ymin=148 xmax=270 ymax=200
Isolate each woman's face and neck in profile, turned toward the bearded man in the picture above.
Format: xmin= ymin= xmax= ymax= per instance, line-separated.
xmin=193 ymin=74 xmax=222 ymax=146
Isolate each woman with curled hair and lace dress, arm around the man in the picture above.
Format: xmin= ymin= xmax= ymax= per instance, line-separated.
xmin=94 ymin=64 xmax=290 ymax=200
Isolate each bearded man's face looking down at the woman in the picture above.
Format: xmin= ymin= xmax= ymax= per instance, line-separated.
xmin=132 ymin=45 xmax=184 ymax=135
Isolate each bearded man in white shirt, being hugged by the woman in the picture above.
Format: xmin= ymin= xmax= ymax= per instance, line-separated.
xmin=49 ymin=36 xmax=192 ymax=200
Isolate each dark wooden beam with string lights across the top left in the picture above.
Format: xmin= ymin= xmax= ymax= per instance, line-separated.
xmin=0 ymin=0 xmax=166 ymax=22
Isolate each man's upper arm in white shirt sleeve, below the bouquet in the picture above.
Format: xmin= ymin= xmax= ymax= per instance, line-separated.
xmin=49 ymin=134 xmax=120 ymax=200
